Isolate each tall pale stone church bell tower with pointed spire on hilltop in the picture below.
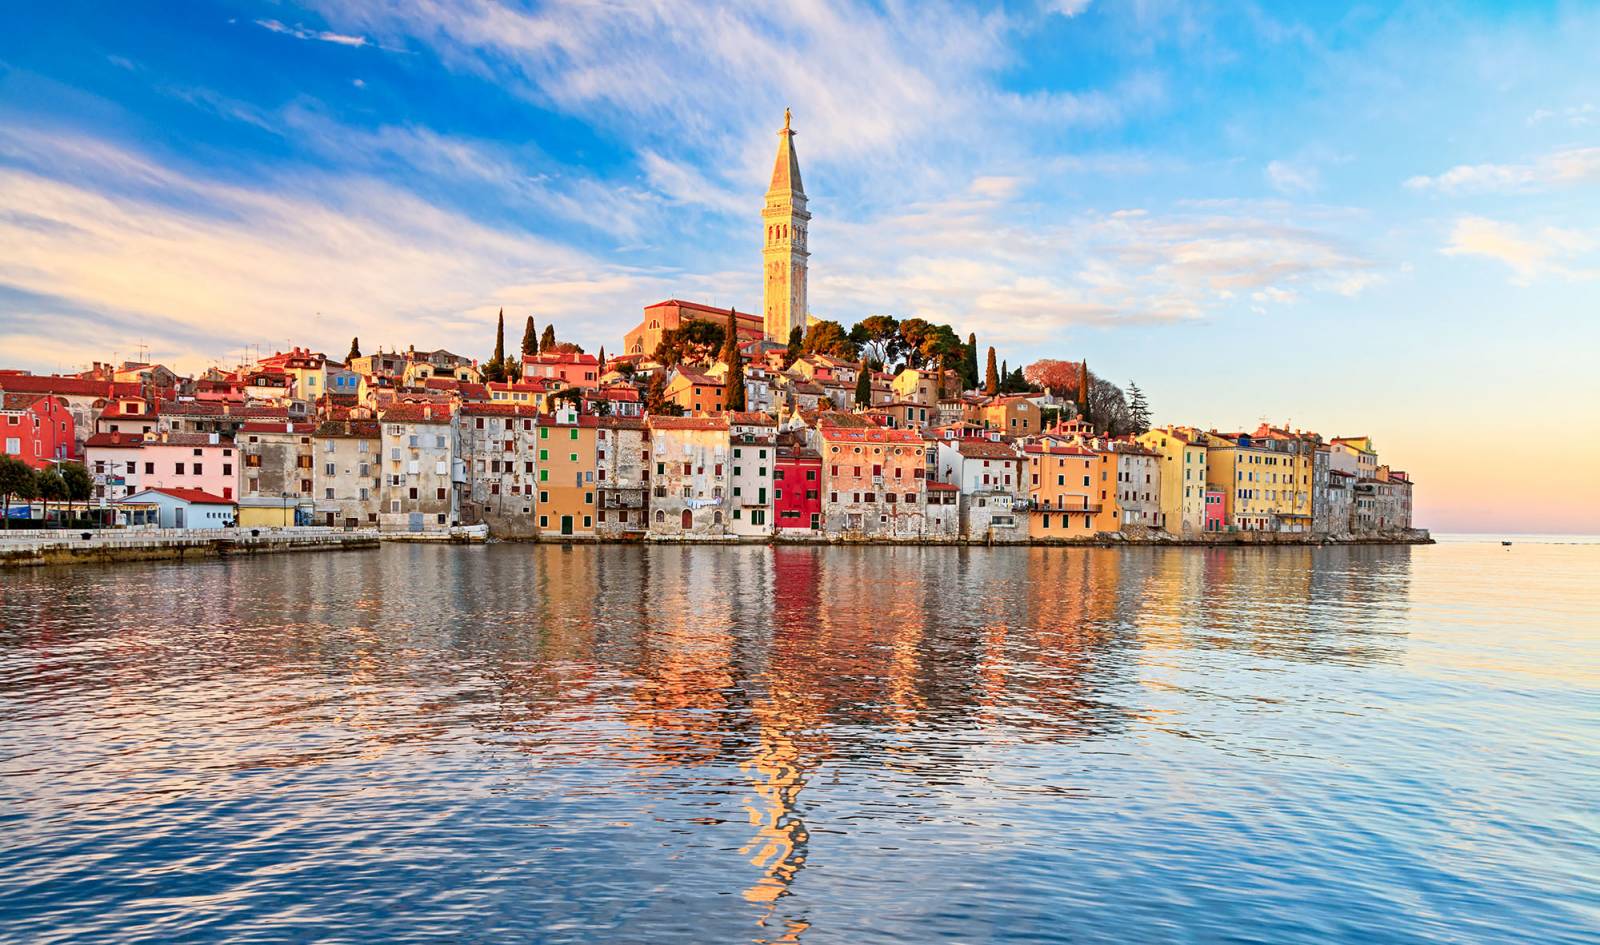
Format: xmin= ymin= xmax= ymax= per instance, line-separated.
xmin=762 ymin=109 xmax=811 ymax=344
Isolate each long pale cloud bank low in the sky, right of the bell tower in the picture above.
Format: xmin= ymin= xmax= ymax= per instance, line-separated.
xmin=811 ymin=177 xmax=1382 ymax=344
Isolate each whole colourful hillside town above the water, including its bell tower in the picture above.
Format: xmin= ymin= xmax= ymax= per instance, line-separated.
xmin=0 ymin=114 xmax=1422 ymax=544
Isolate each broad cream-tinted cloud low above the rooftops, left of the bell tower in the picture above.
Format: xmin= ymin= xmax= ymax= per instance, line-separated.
xmin=0 ymin=130 xmax=707 ymax=369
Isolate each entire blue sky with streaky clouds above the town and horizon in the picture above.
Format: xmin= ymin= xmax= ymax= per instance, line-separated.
xmin=0 ymin=0 xmax=1600 ymax=532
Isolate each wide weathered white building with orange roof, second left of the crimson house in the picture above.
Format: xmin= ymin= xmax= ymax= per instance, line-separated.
xmin=650 ymin=416 xmax=731 ymax=539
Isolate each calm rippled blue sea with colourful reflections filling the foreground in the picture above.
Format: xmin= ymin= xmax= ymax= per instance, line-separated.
xmin=0 ymin=540 xmax=1600 ymax=943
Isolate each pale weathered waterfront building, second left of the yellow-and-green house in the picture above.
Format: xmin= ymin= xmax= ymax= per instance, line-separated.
xmin=378 ymin=403 xmax=466 ymax=531
